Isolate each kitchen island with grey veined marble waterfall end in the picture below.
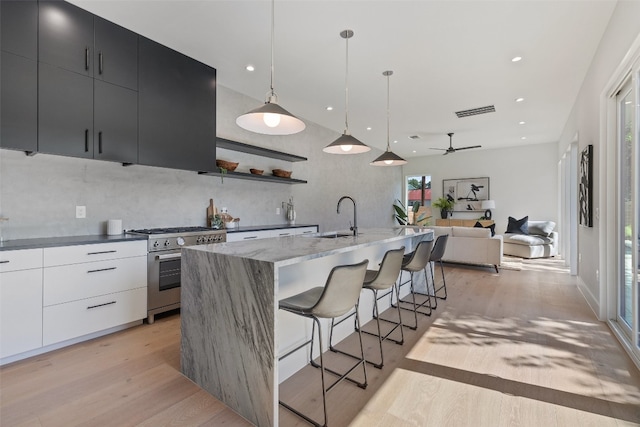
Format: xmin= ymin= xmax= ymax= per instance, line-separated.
xmin=181 ymin=228 xmax=433 ymax=426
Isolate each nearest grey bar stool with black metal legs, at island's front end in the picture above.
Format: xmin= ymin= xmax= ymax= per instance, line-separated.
xmin=279 ymin=259 xmax=369 ymax=426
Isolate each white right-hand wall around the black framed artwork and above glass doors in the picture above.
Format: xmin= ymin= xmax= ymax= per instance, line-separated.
xmin=558 ymin=0 xmax=640 ymax=313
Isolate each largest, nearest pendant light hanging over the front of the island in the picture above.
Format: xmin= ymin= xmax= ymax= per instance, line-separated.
xmin=236 ymin=0 xmax=305 ymax=135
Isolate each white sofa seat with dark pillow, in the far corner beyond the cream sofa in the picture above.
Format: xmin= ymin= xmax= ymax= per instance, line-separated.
xmin=502 ymin=221 xmax=559 ymax=258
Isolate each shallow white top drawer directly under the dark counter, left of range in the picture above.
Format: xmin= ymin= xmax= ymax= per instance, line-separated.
xmin=44 ymin=240 xmax=147 ymax=267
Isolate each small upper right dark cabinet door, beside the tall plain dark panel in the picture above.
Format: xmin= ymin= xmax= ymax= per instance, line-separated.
xmin=93 ymin=16 xmax=138 ymax=90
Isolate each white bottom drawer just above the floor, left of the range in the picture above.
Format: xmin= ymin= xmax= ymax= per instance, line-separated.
xmin=42 ymin=287 xmax=147 ymax=346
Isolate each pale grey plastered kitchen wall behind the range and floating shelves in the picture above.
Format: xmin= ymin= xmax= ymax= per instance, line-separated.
xmin=0 ymin=86 xmax=402 ymax=240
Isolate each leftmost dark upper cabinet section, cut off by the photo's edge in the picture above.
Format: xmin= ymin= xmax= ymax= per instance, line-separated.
xmin=0 ymin=0 xmax=38 ymax=152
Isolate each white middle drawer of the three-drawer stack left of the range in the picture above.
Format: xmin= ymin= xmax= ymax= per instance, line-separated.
xmin=44 ymin=256 xmax=147 ymax=306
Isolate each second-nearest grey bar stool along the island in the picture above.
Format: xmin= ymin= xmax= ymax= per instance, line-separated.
xmin=329 ymin=246 xmax=404 ymax=369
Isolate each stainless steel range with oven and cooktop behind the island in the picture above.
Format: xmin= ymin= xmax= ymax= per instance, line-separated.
xmin=127 ymin=227 xmax=227 ymax=323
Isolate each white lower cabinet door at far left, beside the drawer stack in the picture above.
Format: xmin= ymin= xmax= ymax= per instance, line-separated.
xmin=0 ymin=266 xmax=42 ymax=358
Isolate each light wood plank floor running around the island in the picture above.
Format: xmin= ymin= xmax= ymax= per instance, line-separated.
xmin=0 ymin=261 xmax=640 ymax=427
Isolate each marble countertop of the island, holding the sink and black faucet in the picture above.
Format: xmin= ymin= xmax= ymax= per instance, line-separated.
xmin=183 ymin=227 xmax=433 ymax=266
